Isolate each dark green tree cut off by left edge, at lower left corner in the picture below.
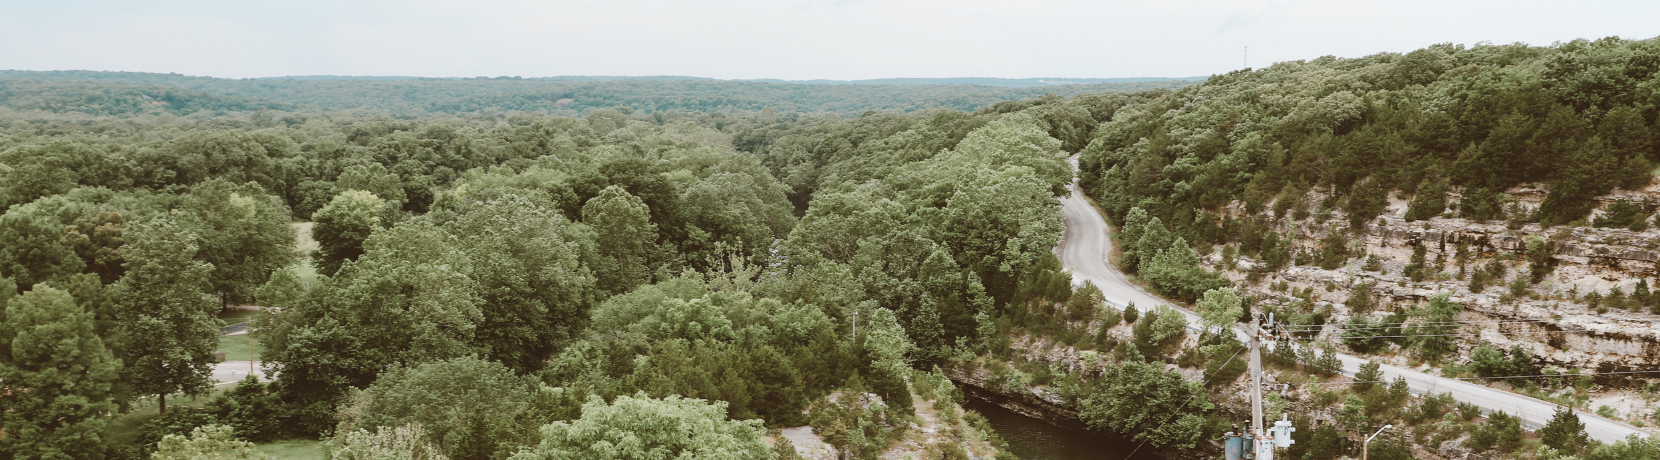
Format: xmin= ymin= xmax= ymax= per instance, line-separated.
xmin=0 ymin=279 xmax=121 ymax=458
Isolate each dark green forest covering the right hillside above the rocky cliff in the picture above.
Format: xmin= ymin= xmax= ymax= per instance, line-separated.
xmin=1081 ymin=38 xmax=1660 ymax=242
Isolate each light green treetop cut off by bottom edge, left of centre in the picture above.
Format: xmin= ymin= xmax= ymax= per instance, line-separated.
xmin=511 ymin=394 xmax=772 ymax=460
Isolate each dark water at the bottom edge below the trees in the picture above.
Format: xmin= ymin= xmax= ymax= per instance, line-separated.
xmin=963 ymin=395 xmax=1162 ymax=460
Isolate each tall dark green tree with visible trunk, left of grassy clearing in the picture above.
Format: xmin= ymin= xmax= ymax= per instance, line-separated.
xmin=116 ymin=218 xmax=222 ymax=412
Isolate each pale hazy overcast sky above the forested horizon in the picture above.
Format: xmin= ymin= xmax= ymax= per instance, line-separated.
xmin=0 ymin=0 xmax=1660 ymax=80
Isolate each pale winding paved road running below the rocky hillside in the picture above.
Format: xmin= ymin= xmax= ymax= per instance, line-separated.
xmin=1059 ymin=158 xmax=1647 ymax=442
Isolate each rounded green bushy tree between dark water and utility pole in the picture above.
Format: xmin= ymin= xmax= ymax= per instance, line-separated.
xmin=1079 ymin=360 xmax=1212 ymax=448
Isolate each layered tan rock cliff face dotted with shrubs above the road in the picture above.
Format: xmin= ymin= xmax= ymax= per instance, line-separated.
xmin=1207 ymin=189 xmax=1660 ymax=385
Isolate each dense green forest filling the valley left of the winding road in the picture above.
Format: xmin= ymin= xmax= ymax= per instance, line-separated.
xmin=0 ymin=71 xmax=1168 ymax=458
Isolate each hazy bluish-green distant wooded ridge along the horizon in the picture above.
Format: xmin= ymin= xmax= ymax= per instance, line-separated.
xmin=0 ymin=70 xmax=1197 ymax=116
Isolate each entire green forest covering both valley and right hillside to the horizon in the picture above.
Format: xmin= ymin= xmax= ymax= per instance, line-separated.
xmin=0 ymin=38 xmax=1660 ymax=458
